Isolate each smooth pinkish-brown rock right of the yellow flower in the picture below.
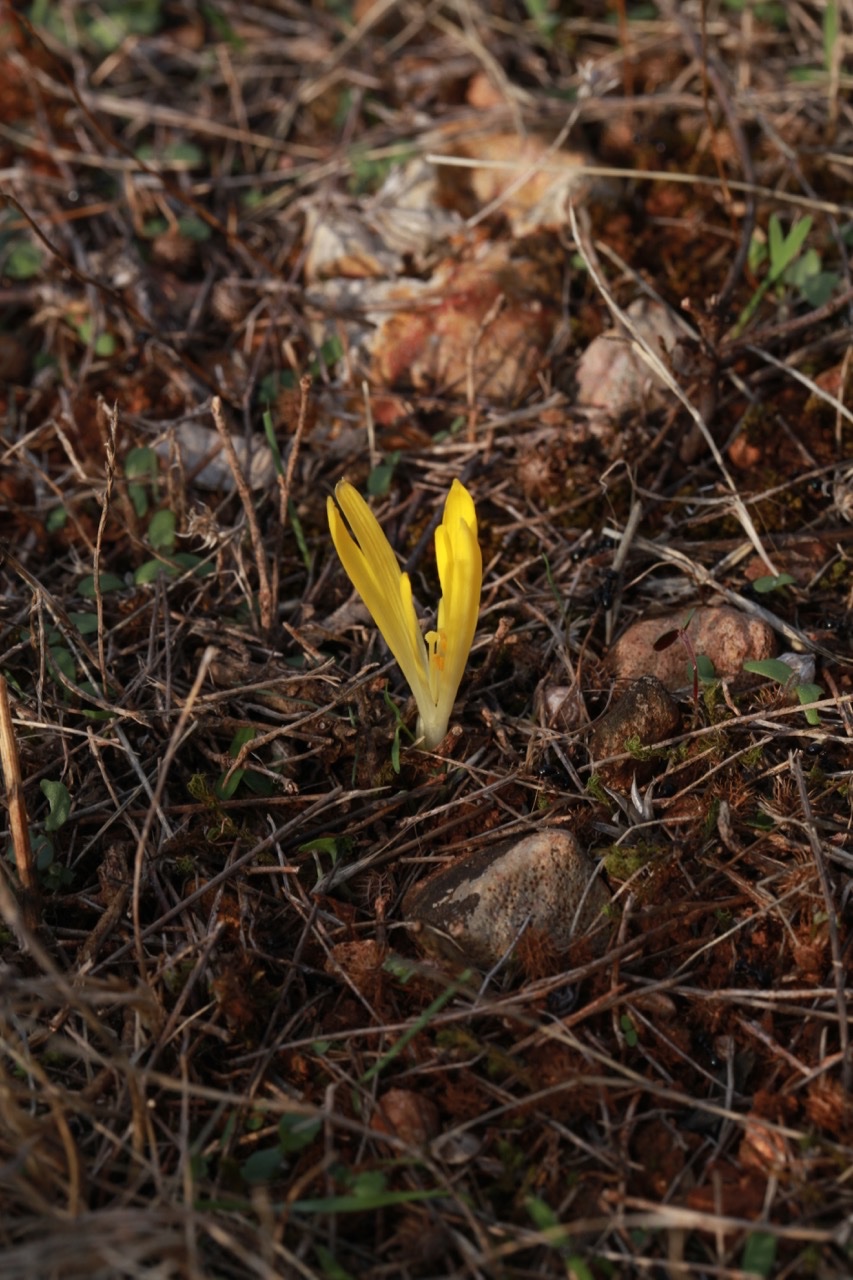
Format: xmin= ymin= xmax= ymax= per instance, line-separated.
xmin=608 ymin=604 xmax=776 ymax=689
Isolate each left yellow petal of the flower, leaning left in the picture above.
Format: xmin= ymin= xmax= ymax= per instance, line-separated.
xmin=327 ymin=480 xmax=432 ymax=713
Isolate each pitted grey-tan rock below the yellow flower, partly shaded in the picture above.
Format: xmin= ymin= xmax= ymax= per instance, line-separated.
xmin=403 ymin=827 xmax=610 ymax=969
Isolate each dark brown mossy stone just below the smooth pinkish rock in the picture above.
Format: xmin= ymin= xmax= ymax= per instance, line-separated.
xmin=589 ymin=676 xmax=681 ymax=790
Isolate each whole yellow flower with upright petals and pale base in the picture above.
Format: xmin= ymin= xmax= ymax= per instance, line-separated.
xmin=327 ymin=480 xmax=483 ymax=750
